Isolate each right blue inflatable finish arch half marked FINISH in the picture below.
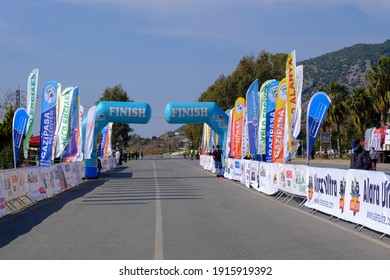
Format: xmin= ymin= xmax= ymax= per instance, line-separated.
xmin=165 ymin=102 xmax=229 ymax=148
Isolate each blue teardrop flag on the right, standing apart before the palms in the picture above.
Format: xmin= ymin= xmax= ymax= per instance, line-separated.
xmin=306 ymin=92 xmax=331 ymax=161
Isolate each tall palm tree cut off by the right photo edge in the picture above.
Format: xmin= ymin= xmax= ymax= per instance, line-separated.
xmin=367 ymin=56 xmax=390 ymax=126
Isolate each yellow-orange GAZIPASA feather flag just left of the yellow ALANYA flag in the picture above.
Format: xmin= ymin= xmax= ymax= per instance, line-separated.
xmin=272 ymin=78 xmax=287 ymax=163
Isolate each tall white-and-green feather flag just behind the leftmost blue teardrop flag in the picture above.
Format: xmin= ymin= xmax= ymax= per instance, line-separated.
xmin=23 ymin=69 xmax=39 ymax=159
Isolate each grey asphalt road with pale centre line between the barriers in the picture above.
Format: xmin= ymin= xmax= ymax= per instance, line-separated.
xmin=0 ymin=157 xmax=390 ymax=260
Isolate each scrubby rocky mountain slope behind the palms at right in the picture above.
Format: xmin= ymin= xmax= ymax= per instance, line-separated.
xmin=297 ymin=40 xmax=390 ymax=100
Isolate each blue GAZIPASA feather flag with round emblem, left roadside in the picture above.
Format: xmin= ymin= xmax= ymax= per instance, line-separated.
xmin=39 ymin=81 xmax=59 ymax=167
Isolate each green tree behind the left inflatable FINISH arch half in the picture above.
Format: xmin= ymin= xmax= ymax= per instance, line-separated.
xmin=96 ymin=85 xmax=133 ymax=149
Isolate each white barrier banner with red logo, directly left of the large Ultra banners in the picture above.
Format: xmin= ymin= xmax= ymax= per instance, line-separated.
xmin=278 ymin=164 xmax=308 ymax=197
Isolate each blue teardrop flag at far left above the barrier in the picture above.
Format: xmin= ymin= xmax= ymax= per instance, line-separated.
xmin=12 ymin=108 xmax=29 ymax=168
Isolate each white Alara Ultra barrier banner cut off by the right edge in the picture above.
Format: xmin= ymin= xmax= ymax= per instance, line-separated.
xmin=344 ymin=169 xmax=390 ymax=234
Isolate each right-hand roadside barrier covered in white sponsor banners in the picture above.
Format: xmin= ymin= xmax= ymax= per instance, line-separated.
xmin=200 ymin=155 xmax=390 ymax=239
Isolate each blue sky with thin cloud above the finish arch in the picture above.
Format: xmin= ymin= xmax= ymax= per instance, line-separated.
xmin=0 ymin=0 xmax=390 ymax=137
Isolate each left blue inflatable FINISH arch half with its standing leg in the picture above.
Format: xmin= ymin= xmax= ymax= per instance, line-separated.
xmin=82 ymin=101 xmax=152 ymax=179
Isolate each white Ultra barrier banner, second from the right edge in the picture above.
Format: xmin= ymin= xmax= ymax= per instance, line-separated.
xmin=305 ymin=166 xmax=348 ymax=219
